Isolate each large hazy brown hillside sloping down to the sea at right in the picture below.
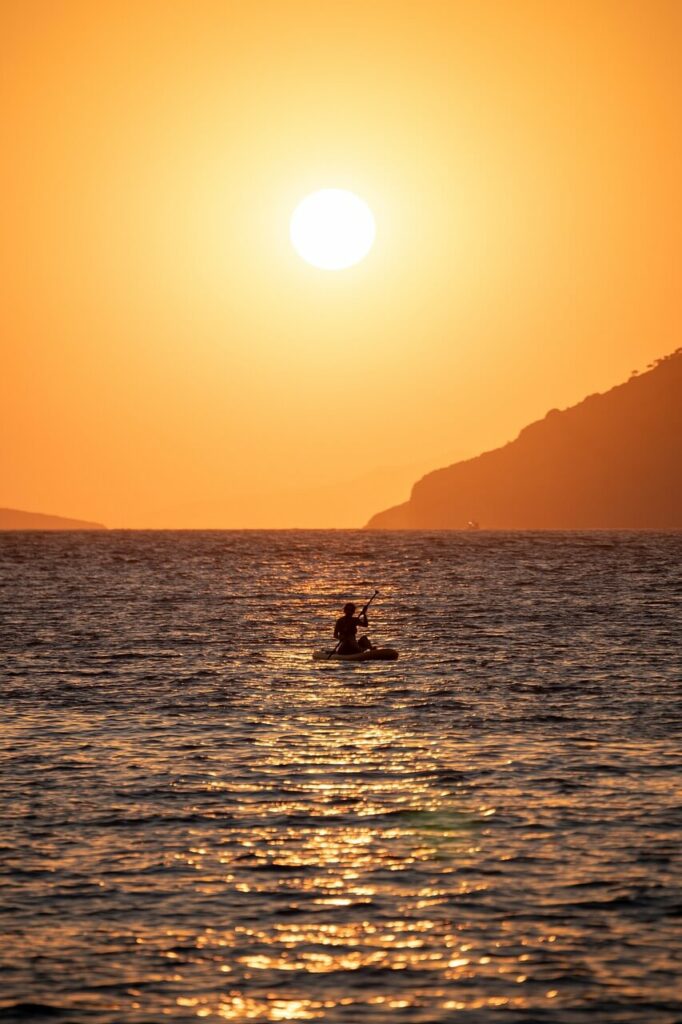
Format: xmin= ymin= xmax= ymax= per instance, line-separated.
xmin=368 ymin=349 xmax=682 ymax=529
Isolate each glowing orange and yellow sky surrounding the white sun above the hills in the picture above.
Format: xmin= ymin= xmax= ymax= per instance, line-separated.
xmin=0 ymin=0 xmax=682 ymax=527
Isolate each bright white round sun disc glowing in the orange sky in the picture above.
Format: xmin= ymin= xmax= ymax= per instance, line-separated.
xmin=289 ymin=188 xmax=377 ymax=270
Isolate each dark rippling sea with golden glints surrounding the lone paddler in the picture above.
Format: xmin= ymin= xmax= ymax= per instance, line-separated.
xmin=0 ymin=532 xmax=682 ymax=1024
